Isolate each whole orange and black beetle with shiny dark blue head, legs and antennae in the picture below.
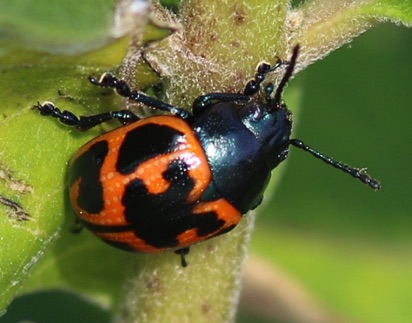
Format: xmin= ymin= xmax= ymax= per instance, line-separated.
xmin=34 ymin=45 xmax=380 ymax=266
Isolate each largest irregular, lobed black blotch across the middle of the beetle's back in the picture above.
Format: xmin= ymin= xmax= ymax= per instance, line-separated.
xmin=116 ymin=159 xmax=235 ymax=248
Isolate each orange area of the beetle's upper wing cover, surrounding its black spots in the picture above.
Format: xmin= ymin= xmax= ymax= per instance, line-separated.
xmin=70 ymin=116 xmax=212 ymax=230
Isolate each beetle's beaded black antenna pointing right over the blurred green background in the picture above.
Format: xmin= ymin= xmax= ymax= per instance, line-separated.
xmin=289 ymin=139 xmax=381 ymax=191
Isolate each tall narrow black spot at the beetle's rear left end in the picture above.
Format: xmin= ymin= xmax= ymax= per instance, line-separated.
xmin=69 ymin=140 xmax=108 ymax=214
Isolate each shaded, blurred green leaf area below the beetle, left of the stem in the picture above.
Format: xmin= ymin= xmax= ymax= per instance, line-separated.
xmin=23 ymin=230 xmax=134 ymax=309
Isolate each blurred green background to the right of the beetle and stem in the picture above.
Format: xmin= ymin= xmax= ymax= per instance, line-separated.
xmin=238 ymin=24 xmax=412 ymax=322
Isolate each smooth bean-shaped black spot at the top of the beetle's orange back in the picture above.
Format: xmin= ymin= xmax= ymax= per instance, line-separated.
xmin=116 ymin=124 xmax=183 ymax=175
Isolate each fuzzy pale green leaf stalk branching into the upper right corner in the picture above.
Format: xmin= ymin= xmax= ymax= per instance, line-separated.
xmin=288 ymin=0 xmax=412 ymax=68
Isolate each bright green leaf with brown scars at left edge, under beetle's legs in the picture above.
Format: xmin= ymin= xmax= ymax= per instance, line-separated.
xmin=0 ymin=64 xmax=119 ymax=312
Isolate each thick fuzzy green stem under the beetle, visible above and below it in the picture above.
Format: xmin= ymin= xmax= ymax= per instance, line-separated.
xmin=117 ymin=0 xmax=288 ymax=322
